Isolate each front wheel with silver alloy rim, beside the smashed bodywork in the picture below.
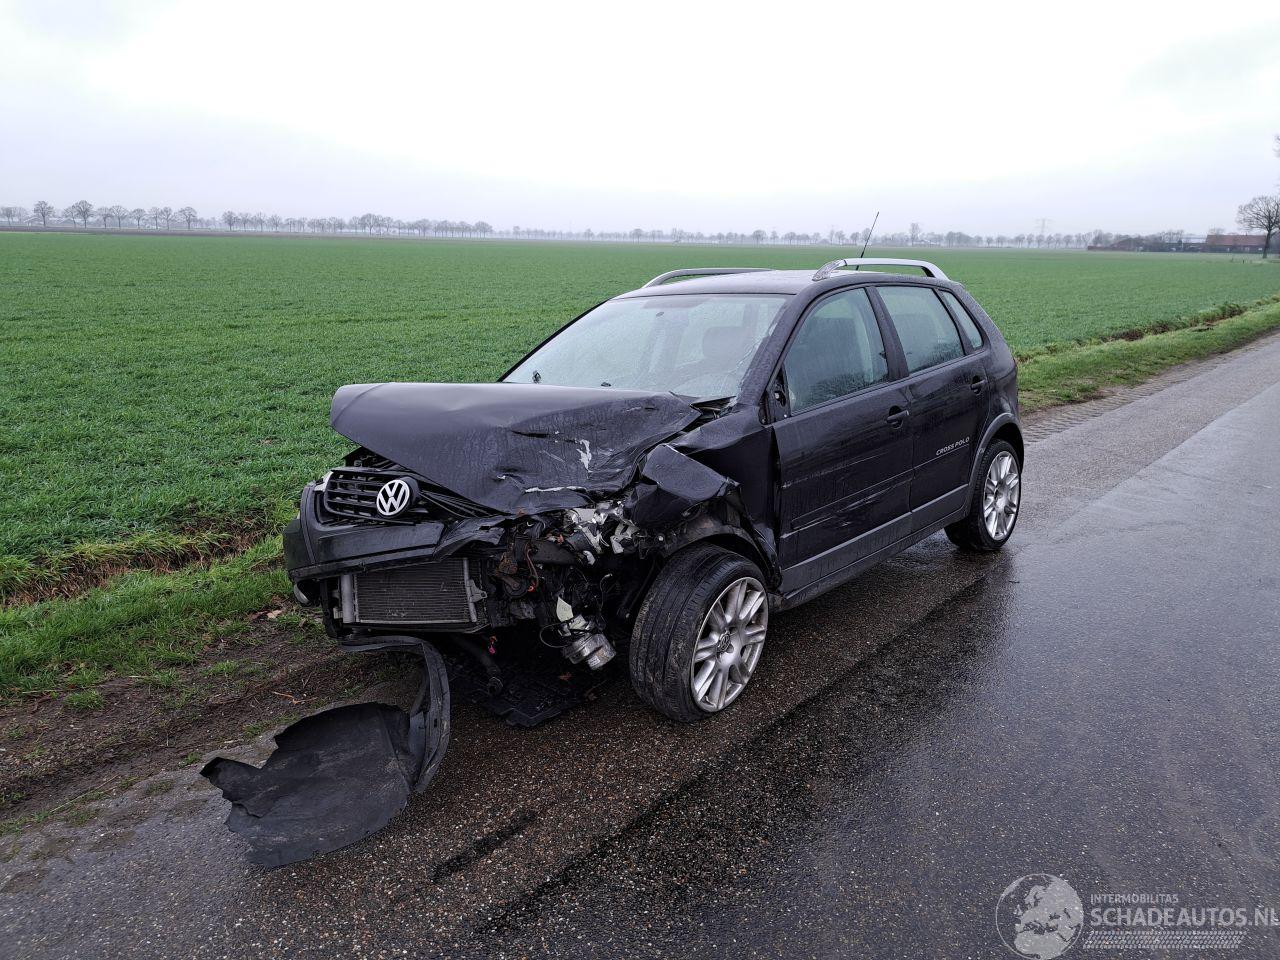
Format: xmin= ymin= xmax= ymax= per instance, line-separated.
xmin=630 ymin=544 xmax=769 ymax=723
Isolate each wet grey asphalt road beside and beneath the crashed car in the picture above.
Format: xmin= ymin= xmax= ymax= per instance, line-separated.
xmin=0 ymin=339 xmax=1280 ymax=957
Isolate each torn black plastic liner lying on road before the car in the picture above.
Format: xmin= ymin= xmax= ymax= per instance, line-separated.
xmin=201 ymin=637 xmax=449 ymax=867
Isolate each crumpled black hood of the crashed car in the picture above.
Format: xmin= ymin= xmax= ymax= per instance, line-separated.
xmin=329 ymin=383 xmax=701 ymax=513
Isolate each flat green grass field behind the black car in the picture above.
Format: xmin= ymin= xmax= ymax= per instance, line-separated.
xmin=0 ymin=234 xmax=1280 ymax=701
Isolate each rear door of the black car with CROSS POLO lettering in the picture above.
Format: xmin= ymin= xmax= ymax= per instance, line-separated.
xmin=877 ymin=284 xmax=991 ymax=530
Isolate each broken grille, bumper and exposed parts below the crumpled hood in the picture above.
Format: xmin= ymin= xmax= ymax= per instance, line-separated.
xmin=285 ymin=449 xmax=634 ymax=667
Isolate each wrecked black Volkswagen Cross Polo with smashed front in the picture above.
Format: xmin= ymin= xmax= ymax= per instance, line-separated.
xmin=284 ymin=259 xmax=1023 ymax=721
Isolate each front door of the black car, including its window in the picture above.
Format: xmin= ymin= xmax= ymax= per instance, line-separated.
xmin=771 ymin=287 xmax=911 ymax=591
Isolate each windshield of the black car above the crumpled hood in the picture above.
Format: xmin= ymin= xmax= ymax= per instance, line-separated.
xmin=504 ymin=293 xmax=787 ymax=399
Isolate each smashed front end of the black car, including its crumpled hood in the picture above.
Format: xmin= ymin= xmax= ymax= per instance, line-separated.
xmin=284 ymin=384 xmax=768 ymax=669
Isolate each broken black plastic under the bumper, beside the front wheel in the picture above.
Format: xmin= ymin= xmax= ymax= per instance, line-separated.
xmin=444 ymin=644 xmax=609 ymax=727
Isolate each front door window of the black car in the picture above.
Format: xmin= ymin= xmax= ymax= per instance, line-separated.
xmin=783 ymin=288 xmax=888 ymax=413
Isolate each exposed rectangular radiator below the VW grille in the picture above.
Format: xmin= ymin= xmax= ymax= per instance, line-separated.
xmin=339 ymin=557 xmax=483 ymax=625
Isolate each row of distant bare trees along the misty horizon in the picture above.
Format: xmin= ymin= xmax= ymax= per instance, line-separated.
xmin=0 ymin=197 xmax=1280 ymax=256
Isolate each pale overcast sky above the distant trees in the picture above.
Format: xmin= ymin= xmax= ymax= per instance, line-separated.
xmin=0 ymin=0 xmax=1280 ymax=234
